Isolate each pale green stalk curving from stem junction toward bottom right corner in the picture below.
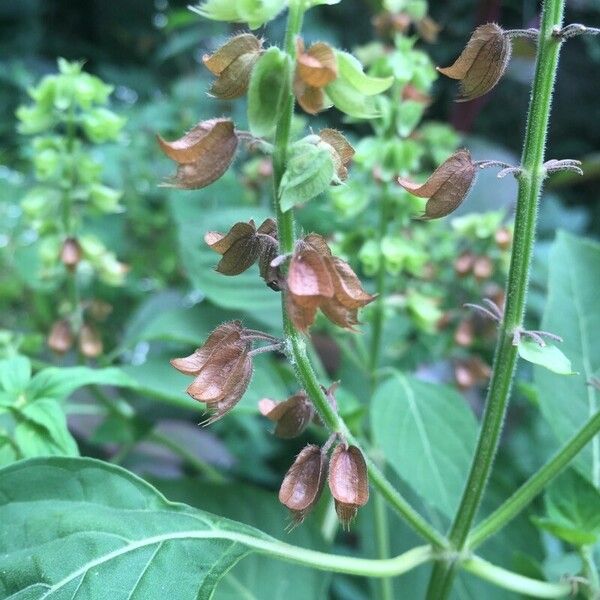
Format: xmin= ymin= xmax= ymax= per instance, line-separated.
xmin=461 ymin=556 xmax=572 ymax=598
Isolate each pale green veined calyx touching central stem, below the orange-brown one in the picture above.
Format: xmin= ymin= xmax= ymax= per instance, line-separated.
xmin=279 ymin=141 xmax=334 ymax=212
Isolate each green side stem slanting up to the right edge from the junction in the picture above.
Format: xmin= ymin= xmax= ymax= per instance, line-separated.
xmin=467 ymin=412 xmax=600 ymax=549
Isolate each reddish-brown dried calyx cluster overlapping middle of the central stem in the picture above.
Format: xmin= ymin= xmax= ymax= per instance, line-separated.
xmin=286 ymin=233 xmax=376 ymax=331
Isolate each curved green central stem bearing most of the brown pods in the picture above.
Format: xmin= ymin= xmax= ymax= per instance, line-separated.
xmin=273 ymin=0 xmax=447 ymax=547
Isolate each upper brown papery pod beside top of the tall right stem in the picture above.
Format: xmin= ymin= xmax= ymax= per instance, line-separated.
xmin=438 ymin=23 xmax=512 ymax=102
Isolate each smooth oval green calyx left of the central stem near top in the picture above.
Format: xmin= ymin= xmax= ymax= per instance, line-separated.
xmin=248 ymin=46 xmax=290 ymax=137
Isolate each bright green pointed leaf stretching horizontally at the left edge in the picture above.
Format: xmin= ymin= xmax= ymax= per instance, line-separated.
xmin=27 ymin=367 xmax=136 ymax=401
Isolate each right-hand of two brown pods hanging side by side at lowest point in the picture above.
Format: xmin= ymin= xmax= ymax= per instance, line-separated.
xmin=329 ymin=444 xmax=369 ymax=527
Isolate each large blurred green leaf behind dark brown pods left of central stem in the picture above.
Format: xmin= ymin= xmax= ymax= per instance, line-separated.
xmin=171 ymin=192 xmax=281 ymax=332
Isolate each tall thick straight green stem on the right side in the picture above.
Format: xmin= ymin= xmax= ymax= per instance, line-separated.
xmin=428 ymin=0 xmax=564 ymax=600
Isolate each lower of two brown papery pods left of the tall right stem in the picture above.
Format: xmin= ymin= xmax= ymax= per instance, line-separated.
xmin=398 ymin=149 xmax=477 ymax=219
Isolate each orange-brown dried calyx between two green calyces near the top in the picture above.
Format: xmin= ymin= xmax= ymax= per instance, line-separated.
xmin=294 ymin=38 xmax=338 ymax=115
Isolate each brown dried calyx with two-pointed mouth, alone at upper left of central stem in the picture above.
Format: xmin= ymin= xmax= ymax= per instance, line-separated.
xmin=157 ymin=119 xmax=238 ymax=190
